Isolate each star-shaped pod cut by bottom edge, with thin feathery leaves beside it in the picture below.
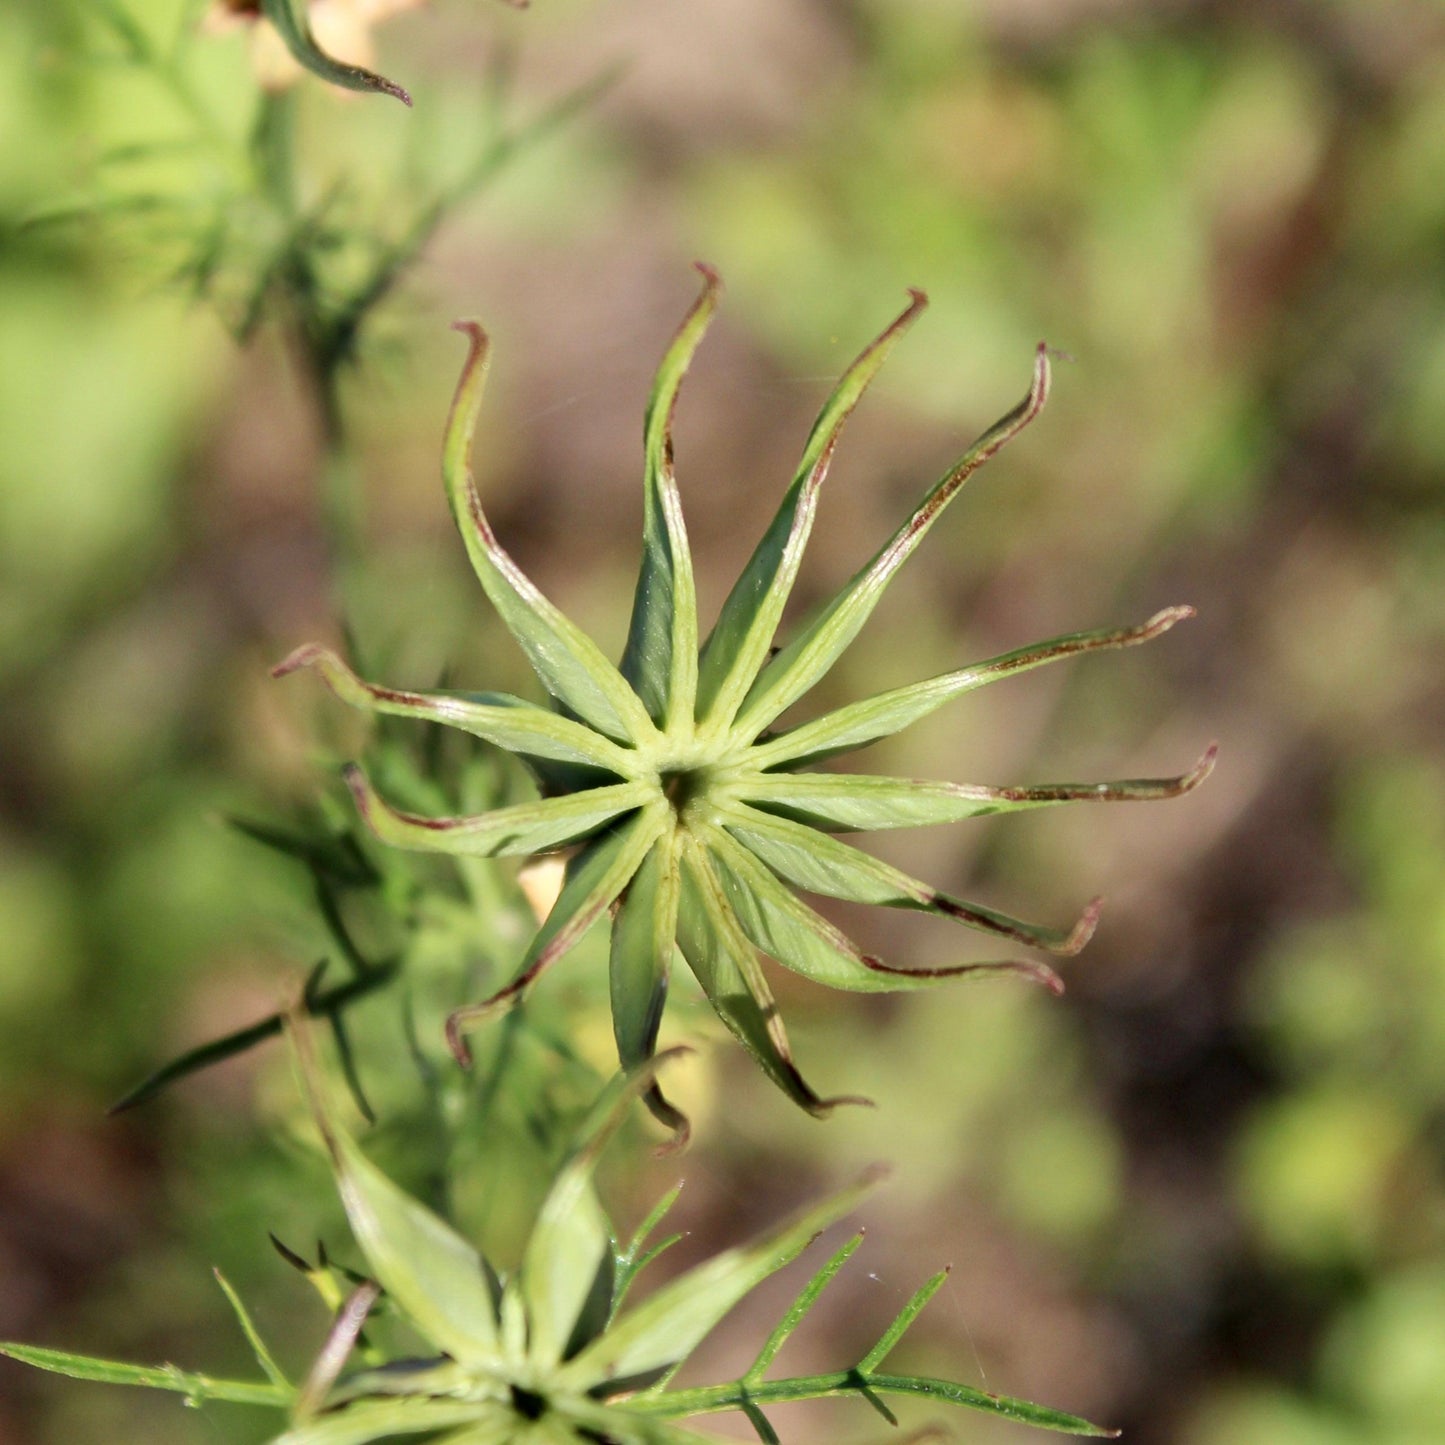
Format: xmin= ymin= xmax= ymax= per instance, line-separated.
xmin=0 ymin=1046 xmax=1117 ymax=1445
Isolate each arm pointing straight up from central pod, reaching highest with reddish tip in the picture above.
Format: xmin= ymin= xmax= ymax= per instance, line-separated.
xmin=621 ymin=266 xmax=721 ymax=727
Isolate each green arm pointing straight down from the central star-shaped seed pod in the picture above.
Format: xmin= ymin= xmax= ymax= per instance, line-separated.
xmin=610 ymin=835 xmax=689 ymax=1149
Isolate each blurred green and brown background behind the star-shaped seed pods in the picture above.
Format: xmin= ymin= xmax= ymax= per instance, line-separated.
xmin=0 ymin=0 xmax=1445 ymax=1445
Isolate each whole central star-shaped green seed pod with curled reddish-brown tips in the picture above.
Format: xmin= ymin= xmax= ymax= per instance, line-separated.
xmin=275 ymin=267 xmax=1214 ymax=1143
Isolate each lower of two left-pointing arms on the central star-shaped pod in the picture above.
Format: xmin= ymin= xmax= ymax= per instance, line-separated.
xmin=342 ymin=764 xmax=657 ymax=858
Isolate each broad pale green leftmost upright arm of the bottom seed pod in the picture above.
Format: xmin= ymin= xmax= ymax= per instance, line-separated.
xmin=292 ymin=1026 xmax=497 ymax=1366
